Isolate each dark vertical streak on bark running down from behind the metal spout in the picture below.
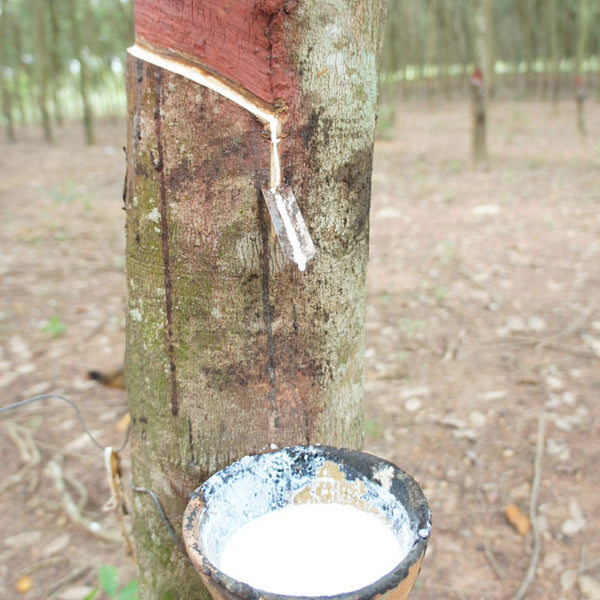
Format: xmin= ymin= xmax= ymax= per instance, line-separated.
xmin=256 ymin=180 xmax=279 ymax=427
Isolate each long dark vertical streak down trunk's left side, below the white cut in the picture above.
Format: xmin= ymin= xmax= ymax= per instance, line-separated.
xmin=154 ymin=68 xmax=179 ymax=416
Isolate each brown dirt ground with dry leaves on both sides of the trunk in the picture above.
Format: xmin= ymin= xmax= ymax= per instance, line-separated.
xmin=0 ymin=103 xmax=600 ymax=600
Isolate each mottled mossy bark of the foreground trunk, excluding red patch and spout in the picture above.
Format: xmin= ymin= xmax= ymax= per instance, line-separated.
xmin=125 ymin=0 xmax=385 ymax=599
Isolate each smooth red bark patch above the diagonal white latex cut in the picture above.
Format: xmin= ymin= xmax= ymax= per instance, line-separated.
xmin=135 ymin=0 xmax=292 ymax=103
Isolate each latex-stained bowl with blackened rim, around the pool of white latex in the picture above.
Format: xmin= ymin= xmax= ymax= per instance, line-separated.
xmin=183 ymin=445 xmax=431 ymax=600
